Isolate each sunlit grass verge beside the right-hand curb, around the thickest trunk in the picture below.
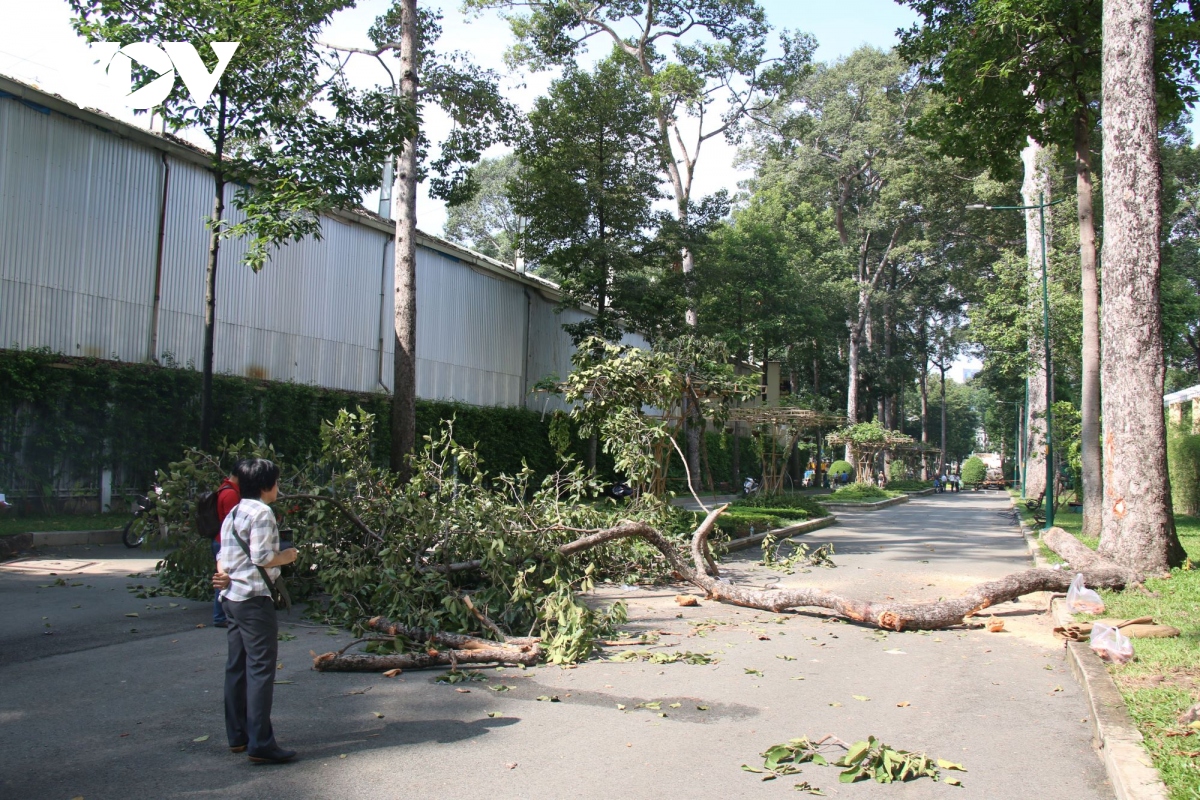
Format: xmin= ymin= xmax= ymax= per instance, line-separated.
xmin=1016 ymin=498 xmax=1200 ymax=800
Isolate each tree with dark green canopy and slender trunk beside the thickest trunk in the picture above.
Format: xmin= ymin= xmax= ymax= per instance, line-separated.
xmin=899 ymin=0 xmax=1200 ymax=536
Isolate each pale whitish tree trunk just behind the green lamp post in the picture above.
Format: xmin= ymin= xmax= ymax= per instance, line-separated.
xmin=1021 ymin=139 xmax=1050 ymax=498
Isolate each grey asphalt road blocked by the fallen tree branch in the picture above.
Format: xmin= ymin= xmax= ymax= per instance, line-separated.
xmin=0 ymin=493 xmax=1112 ymax=800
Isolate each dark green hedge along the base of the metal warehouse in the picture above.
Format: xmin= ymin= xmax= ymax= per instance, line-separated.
xmin=0 ymin=350 xmax=561 ymax=494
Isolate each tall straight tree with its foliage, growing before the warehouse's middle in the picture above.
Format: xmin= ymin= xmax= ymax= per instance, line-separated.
xmin=325 ymin=0 xmax=515 ymax=476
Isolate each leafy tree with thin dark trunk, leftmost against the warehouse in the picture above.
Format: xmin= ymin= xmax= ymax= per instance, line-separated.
xmin=71 ymin=0 xmax=415 ymax=449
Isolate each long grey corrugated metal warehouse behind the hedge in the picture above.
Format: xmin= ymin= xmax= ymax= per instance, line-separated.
xmin=0 ymin=77 xmax=619 ymax=407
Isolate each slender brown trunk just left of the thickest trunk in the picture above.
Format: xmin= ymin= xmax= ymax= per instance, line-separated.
xmin=1075 ymin=108 xmax=1104 ymax=537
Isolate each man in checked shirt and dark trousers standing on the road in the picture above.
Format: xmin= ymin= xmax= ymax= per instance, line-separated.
xmin=212 ymin=458 xmax=296 ymax=764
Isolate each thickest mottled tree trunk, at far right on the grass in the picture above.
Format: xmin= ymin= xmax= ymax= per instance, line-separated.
xmin=1099 ymin=0 xmax=1186 ymax=573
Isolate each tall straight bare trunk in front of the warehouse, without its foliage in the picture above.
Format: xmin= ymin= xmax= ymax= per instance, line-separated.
xmin=391 ymin=0 xmax=418 ymax=480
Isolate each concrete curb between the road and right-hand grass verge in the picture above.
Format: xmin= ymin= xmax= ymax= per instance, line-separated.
xmin=1013 ymin=501 xmax=1168 ymax=800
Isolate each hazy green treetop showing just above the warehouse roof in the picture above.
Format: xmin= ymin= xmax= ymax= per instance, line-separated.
xmin=443 ymin=154 xmax=523 ymax=264
